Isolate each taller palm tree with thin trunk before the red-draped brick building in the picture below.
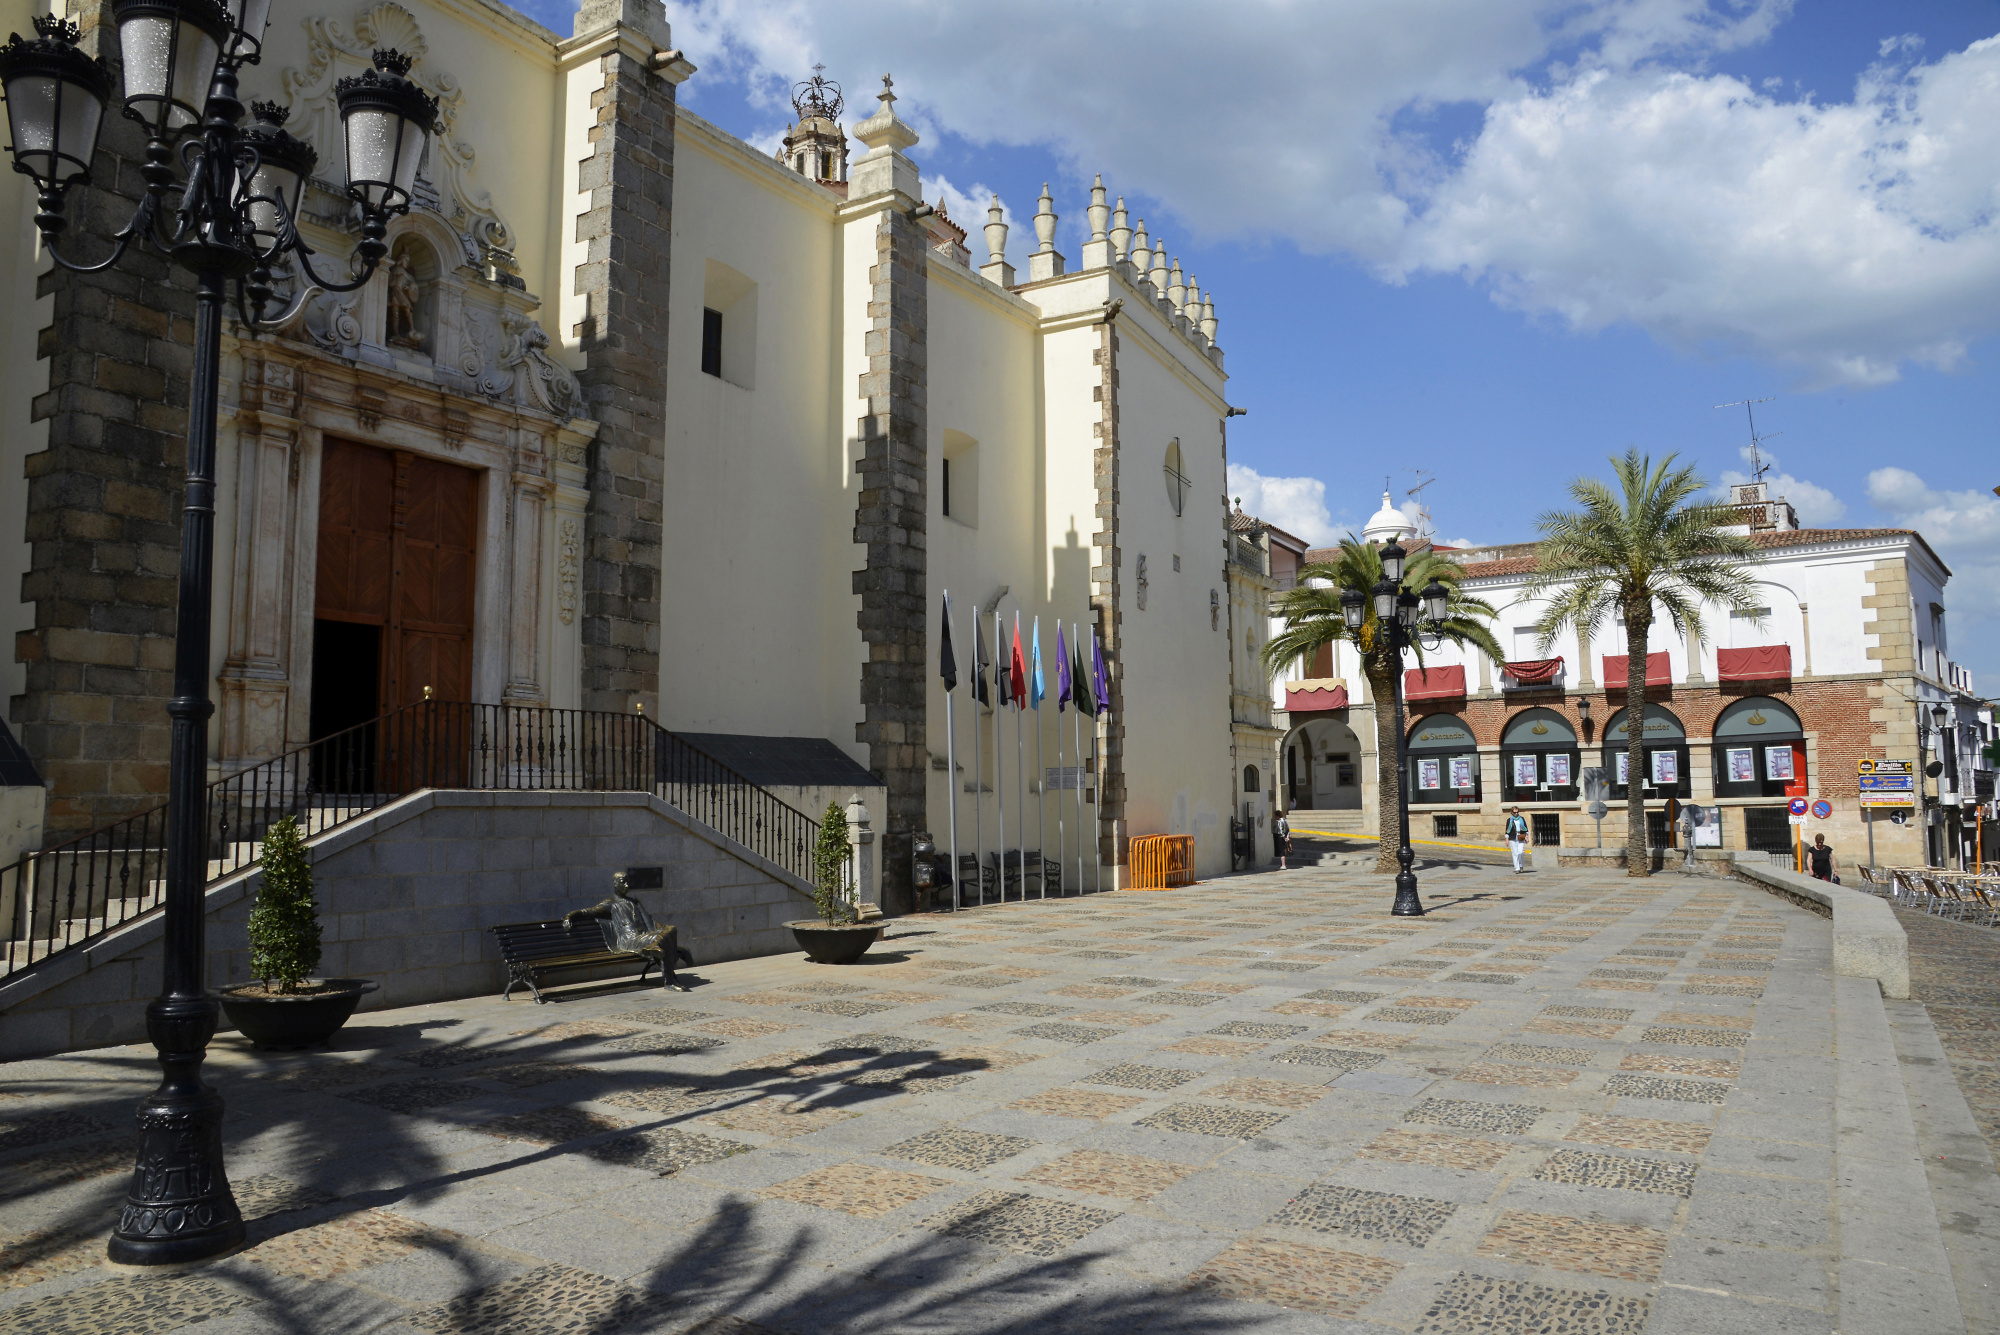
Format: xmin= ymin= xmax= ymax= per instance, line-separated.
xmin=1524 ymin=450 xmax=1756 ymax=875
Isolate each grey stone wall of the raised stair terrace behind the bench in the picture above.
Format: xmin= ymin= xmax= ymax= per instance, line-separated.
xmin=0 ymin=791 xmax=812 ymax=1059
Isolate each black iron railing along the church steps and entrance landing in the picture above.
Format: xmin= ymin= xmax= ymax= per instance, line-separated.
xmin=0 ymin=699 xmax=820 ymax=977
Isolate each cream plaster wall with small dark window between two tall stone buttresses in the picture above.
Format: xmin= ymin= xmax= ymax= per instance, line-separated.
xmin=660 ymin=112 xmax=852 ymax=759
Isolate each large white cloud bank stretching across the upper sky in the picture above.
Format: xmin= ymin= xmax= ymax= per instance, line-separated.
xmin=668 ymin=0 xmax=2000 ymax=384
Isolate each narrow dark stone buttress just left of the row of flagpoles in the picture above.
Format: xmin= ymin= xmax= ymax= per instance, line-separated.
xmin=854 ymin=206 xmax=930 ymax=913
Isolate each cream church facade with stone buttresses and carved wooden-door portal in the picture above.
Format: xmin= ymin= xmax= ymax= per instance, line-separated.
xmin=0 ymin=0 xmax=1232 ymax=909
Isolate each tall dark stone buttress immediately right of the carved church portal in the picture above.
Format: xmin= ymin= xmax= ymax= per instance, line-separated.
xmin=576 ymin=41 xmax=674 ymax=717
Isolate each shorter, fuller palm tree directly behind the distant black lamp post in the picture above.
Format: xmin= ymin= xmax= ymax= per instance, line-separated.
xmin=1262 ymin=534 xmax=1502 ymax=871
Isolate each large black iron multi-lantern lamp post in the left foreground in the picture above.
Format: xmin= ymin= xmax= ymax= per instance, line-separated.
xmin=0 ymin=10 xmax=438 ymax=1265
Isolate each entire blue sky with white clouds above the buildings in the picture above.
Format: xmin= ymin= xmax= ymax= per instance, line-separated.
xmin=526 ymin=0 xmax=2000 ymax=693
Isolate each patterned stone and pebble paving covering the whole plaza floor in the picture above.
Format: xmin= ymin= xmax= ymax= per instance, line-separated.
xmin=0 ymin=859 xmax=2000 ymax=1335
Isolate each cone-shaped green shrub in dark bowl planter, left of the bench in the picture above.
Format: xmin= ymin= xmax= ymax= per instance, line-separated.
xmin=220 ymin=815 xmax=376 ymax=1049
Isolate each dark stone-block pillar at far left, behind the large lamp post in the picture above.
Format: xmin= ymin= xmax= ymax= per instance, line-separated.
xmin=6 ymin=4 xmax=194 ymax=837
